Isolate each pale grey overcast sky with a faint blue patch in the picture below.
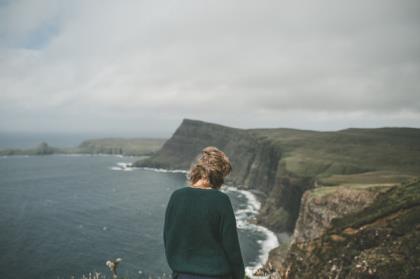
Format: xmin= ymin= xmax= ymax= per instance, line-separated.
xmin=0 ymin=0 xmax=420 ymax=137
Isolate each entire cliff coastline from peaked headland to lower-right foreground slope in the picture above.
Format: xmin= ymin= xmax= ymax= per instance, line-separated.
xmin=135 ymin=119 xmax=420 ymax=278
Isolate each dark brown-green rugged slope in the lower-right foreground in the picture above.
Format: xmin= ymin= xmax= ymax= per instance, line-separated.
xmin=278 ymin=182 xmax=420 ymax=278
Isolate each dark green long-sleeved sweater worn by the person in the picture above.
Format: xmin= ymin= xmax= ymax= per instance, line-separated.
xmin=163 ymin=186 xmax=245 ymax=279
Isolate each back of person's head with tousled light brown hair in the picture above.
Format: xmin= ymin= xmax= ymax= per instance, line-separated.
xmin=187 ymin=146 xmax=232 ymax=189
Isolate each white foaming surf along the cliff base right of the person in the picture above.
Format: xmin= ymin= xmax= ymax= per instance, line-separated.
xmin=222 ymin=185 xmax=279 ymax=278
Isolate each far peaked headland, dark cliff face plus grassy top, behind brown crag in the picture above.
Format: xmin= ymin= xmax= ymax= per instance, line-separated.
xmin=134 ymin=119 xmax=420 ymax=233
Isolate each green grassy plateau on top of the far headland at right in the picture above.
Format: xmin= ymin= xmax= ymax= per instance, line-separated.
xmin=250 ymin=128 xmax=420 ymax=177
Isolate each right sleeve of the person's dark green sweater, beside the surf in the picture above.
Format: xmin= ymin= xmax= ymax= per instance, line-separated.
xmin=221 ymin=197 xmax=245 ymax=279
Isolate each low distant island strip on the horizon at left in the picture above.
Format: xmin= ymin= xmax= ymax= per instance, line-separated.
xmin=0 ymin=138 xmax=166 ymax=156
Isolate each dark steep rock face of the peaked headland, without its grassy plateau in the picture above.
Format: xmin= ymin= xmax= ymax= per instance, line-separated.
xmin=134 ymin=119 xmax=302 ymax=231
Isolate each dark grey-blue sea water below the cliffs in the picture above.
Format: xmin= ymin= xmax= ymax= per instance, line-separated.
xmin=0 ymin=155 xmax=267 ymax=279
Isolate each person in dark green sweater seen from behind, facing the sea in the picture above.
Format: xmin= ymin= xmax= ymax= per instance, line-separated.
xmin=163 ymin=146 xmax=245 ymax=279
